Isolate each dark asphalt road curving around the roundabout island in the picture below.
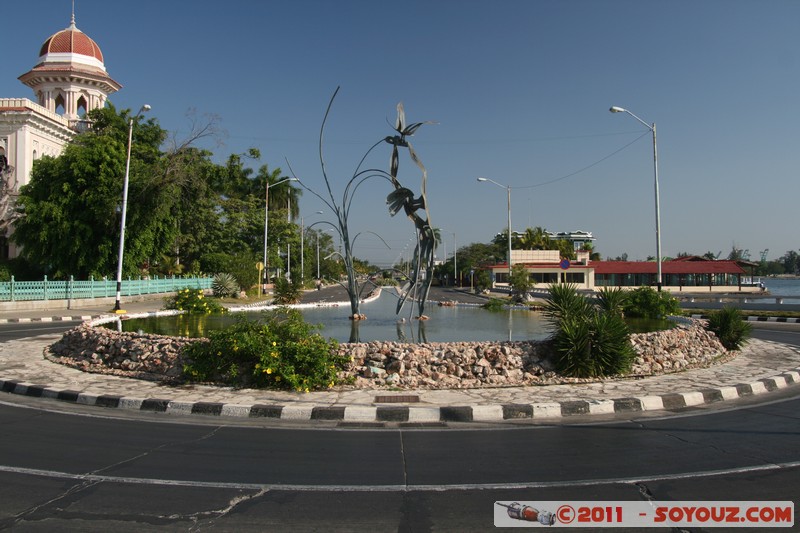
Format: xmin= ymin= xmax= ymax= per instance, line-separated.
xmin=0 ymin=306 xmax=800 ymax=532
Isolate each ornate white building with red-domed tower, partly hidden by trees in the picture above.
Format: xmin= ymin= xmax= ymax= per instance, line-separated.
xmin=0 ymin=13 xmax=122 ymax=258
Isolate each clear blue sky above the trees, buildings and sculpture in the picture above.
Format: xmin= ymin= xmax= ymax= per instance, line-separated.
xmin=0 ymin=0 xmax=800 ymax=263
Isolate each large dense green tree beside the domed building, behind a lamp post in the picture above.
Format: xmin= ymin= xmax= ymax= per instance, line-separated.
xmin=13 ymin=107 xmax=169 ymax=278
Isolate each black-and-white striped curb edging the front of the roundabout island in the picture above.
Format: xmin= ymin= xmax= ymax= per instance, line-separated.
xmin=0 ymin=367 xmax=800 ymax=424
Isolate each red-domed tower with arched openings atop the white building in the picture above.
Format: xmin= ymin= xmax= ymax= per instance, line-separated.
xmin=19 ymin=13 xmax=122 ymax=122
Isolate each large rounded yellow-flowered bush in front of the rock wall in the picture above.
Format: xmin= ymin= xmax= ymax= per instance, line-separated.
xmin=183 ymin=308 xmax=349 ymax=392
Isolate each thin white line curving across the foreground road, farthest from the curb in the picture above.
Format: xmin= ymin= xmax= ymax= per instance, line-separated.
xmin=0 ymin=461 xmax=800 ymax=492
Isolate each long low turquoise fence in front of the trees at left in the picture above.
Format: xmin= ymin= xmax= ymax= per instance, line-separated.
xmin=0 ymin=276 xmax=213 ymax=302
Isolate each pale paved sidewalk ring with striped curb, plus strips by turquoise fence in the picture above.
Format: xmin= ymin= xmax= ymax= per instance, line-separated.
xmin=0 ymin=298 xmax=800 ymax=424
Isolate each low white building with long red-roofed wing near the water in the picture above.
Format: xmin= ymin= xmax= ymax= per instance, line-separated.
xmin=487 ymin=250 xmax=761 ymax=292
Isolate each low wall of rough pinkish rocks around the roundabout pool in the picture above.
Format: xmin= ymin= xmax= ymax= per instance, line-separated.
xmin=45 ymin=321 xmax=727 ymax=389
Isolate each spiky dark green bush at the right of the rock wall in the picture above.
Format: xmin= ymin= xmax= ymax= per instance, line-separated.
xmin=544 ymin=285 xmax=634 ymax=378
